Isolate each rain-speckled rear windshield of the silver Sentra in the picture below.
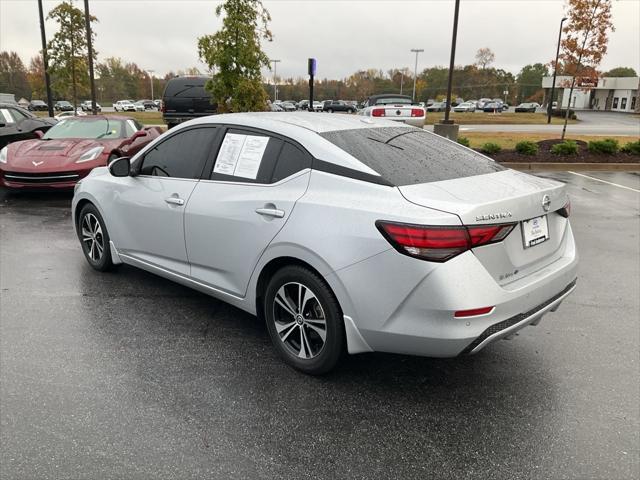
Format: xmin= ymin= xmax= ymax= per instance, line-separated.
xmin=320 ymin=127 xmax=504 ymax=186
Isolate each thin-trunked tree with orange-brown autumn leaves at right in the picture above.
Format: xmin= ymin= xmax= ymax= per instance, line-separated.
xmin=561 ymin=0 xmax=615 ymax=139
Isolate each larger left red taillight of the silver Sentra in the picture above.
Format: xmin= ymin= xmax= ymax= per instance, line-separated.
xmin=376 ymin=220 xmax=516 ymax=262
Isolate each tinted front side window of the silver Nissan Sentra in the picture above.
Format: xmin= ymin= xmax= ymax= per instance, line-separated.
xmin=140 ymin=127 xmax=217 ymax=179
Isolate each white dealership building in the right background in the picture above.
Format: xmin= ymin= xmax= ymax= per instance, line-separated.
xmin=542 ymin=75 xmax=640 ymax=112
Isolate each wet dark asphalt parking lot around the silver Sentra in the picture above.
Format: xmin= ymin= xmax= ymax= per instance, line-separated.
xmin=0 ymin=172 xmax=640 ymax=479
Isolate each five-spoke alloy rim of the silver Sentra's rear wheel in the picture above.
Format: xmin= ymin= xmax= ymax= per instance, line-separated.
xmin=273 ymin=282 xmax=327 ymax=359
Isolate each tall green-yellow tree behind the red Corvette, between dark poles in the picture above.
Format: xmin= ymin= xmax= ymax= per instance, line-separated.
xmin=47 ymin=0 xmax=98 ymax=105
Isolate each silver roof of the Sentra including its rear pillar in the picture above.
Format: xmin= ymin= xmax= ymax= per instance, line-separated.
xmin=175 ymin=112 xmax=416 ymax=176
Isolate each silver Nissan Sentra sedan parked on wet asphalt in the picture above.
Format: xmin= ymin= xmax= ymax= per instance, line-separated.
xmin=72 ymin=112 xmax=578 ymax=374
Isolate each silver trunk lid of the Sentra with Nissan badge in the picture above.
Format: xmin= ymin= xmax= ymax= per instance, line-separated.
xmin=398 ymin=170 xmax=568 ymax=285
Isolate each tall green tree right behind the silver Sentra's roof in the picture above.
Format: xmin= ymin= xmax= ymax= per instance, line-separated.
xmin=198 ymin=0 xmax=272 ymax=112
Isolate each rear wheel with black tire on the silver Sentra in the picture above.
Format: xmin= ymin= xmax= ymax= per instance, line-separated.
xmin=264 ymin=265 xmax=345 ymax=375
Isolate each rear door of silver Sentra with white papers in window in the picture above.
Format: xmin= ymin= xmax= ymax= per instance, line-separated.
xmin=185 ymin=128 xmax=312 ymax=296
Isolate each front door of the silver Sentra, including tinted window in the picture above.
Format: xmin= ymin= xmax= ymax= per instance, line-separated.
xmin=109 ymin=127 xmax=218 ymax=275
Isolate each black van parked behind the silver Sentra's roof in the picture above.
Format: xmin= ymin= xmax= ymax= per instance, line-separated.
xmin=162 ymin=76 xmax=217 ymax=128
